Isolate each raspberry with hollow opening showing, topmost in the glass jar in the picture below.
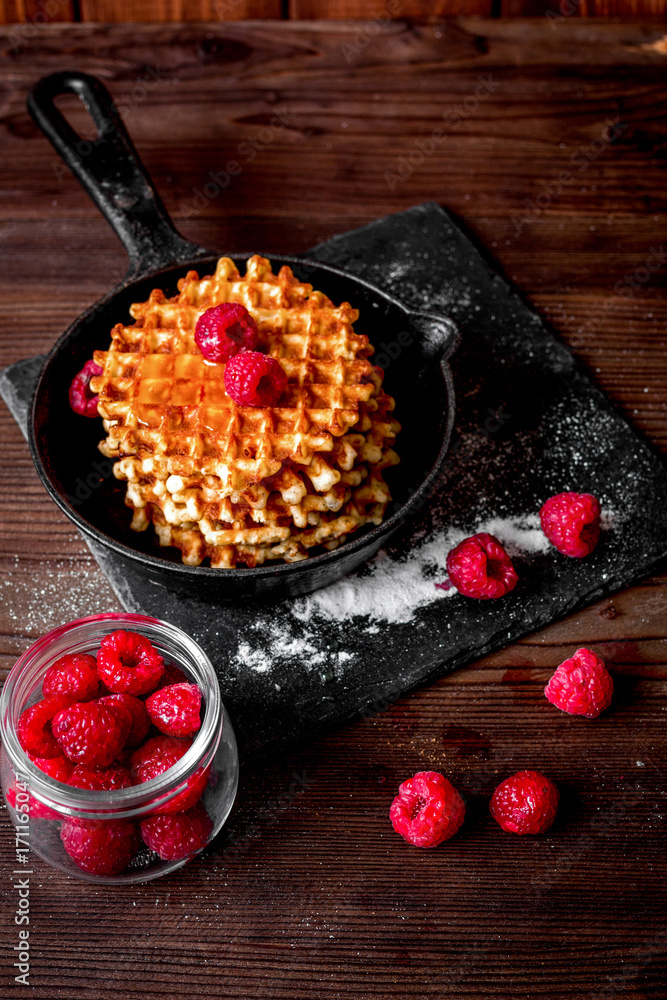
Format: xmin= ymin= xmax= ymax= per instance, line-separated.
xmin=97 ymin=631 xmax=164 ymax=695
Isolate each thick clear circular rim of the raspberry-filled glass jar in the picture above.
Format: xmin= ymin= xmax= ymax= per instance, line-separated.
xmin=0 ymin=611 xmax=224 ymax=819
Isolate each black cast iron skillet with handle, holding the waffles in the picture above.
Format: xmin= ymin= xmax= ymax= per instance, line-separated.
xmin=28 ymin=72 xmax=457 ymax=603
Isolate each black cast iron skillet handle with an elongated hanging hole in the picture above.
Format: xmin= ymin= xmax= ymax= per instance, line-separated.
xmin=28 ymin=70 xmax=210 ymax=277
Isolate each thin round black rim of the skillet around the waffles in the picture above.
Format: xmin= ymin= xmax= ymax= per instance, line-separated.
xmin=28 ymin=251 xmax=461 ymax=582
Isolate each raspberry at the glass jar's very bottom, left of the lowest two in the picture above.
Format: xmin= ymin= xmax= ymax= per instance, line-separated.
xmin=60 ymin=818 xmax=141 ymax=875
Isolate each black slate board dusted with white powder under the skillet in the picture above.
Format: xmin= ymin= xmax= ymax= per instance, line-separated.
xmin=0 ymin=204 xmax=667 ymax=758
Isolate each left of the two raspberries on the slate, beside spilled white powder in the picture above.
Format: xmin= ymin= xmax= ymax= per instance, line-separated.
xmin=447 ymin=532 xmax=519 ymax=600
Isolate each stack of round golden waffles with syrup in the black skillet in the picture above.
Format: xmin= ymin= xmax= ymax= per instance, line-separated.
xmin=91 ymin=256 xmax=400 ymax=567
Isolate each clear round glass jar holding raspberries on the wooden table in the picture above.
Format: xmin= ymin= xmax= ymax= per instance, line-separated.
xmin=0 ymin=613 xmax=239 ymax=882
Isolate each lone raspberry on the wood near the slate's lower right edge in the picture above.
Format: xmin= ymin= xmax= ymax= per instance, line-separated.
xmin=544 ymin=647 xmax=614 ymax=719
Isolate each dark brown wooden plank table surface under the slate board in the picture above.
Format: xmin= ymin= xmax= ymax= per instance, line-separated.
xmin=0 ymin=17 xmax=667 ymax=1000
